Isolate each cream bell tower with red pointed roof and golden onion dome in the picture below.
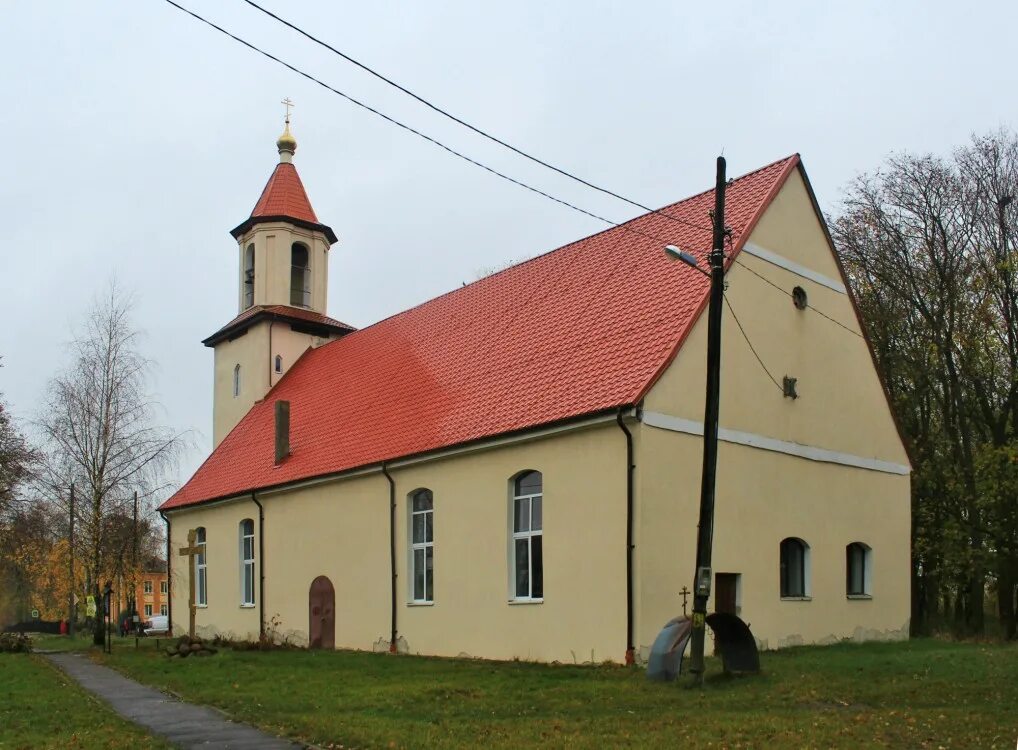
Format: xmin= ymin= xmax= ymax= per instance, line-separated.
xmin=202 ymin=110 xmax=353 ymax=447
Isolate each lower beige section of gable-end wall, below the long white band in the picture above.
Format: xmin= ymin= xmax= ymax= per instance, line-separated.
xmin=636 ymin=424 xmax=909 ymax=656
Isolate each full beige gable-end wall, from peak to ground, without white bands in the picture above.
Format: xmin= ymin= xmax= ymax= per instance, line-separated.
xmin=636 ymin=166 xmax=910 ymax=647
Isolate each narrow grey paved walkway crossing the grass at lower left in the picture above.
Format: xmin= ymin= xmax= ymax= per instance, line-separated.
xmin=44 ymin=653 xmax=302 ymax=750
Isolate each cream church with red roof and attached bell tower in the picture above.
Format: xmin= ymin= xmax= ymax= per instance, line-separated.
xmin=161 ymin=118 xmax=910 ymax=662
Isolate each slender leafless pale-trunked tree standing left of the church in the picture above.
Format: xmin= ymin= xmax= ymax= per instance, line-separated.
xmin=38 ymin=283 xmax=184 ymax=639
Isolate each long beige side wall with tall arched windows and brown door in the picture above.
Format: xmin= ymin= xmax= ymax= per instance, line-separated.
xmin=170 ymin=422 xmax=626 ymax=661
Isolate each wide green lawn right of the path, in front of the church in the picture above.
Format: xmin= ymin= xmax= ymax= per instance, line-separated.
xmin=91 ymin=640 xmax=1018 ymax=750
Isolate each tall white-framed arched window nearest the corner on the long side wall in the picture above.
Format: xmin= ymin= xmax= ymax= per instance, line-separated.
xmin=509 ymin=471 xmax=545 ymax=600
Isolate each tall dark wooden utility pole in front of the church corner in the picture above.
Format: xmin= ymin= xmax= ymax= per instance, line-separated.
xmin=689 ymin=157 xmax=726 ymax=685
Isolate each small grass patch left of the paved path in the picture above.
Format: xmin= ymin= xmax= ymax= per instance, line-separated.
xmin=0 ymin=653 xmax=169 ymax=750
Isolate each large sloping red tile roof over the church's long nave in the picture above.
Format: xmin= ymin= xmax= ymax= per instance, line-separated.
xmin=162 ymin=156 xmax=799 ymax=510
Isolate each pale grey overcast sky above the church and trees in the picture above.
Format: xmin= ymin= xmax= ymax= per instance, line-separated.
xmin=0 ymin=0 xmax=1018 ymax=496
